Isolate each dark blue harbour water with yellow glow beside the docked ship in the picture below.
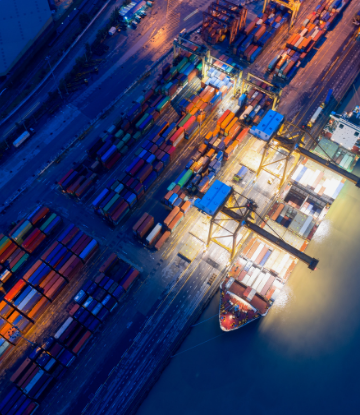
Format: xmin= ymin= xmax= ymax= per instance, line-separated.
xmin=138 ymin=176 xmax=360 ymax=415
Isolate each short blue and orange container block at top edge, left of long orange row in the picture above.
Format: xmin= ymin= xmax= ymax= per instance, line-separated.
xmin=232 ymin=2 xmax=289 ymax=63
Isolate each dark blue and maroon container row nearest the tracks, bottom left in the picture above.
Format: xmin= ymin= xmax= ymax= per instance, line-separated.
xmin=0 ymin=254 xmax=139 ymax=415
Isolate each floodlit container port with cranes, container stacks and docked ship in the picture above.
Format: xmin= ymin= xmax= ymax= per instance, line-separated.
xmin=0 ymin=0 xmax=360 ymax=415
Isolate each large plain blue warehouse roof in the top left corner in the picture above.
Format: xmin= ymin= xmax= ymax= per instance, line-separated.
xmin=0 ymin=0 xmax=52 ymax=75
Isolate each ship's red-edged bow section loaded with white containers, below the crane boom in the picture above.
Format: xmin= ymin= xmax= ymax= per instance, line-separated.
xmin=220 ymin=236 xmax=297 ymax=330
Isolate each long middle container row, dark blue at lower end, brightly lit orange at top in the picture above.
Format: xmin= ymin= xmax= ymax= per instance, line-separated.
xmin=92 ymin=58 xmax=233 ymax=226
